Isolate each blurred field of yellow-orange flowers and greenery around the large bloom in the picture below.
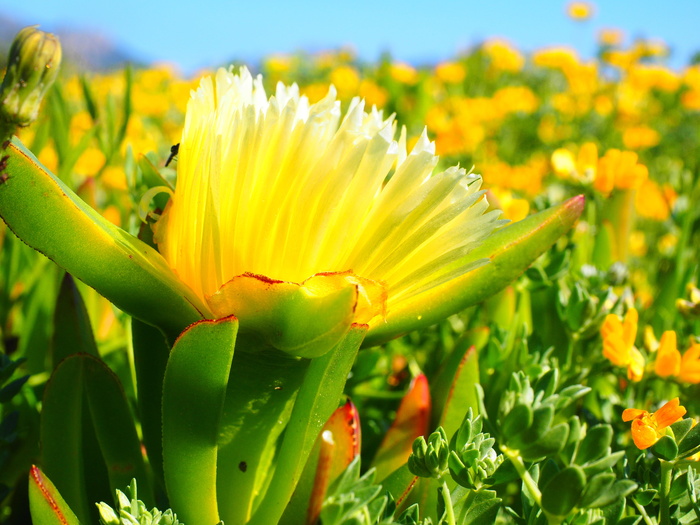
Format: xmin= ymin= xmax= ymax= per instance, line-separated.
xmin=0 ymin=23 xmax=700 ymax=525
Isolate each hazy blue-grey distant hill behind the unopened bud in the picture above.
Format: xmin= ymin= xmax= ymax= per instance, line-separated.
xmin=0 ymin=13 xmax=141 ymax=71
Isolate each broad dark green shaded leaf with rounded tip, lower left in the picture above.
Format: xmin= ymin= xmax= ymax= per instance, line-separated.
xmin=41 ymin=354 xmax=154 ymax=522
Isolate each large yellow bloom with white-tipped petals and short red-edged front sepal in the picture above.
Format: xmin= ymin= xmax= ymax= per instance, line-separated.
xmin=155 ymin=68 xmax=500 ymax=357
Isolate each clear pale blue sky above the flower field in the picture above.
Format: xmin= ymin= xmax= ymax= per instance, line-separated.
xmin=5 ymin=0 xmax=700 ymax=73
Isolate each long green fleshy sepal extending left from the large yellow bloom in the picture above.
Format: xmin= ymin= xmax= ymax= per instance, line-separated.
xmin=0 ymin=139 xmax=208 ymax=337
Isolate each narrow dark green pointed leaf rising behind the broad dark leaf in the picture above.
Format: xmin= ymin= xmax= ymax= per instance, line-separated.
xmin=51 ymin=273 xmax=99 ymax=368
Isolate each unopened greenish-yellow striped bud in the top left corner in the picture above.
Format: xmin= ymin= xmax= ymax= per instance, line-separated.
xmin=0 ymin=26 xmax=61 ymax=132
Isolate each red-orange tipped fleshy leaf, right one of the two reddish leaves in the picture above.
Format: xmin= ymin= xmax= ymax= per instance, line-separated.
xmin=372 ymin=374 xmax=430 ymax=481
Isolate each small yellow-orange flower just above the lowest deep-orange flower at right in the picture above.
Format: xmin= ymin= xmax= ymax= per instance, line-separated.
xmin=600 ymin=308 xmax=645 ymax=381
